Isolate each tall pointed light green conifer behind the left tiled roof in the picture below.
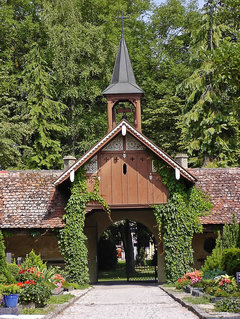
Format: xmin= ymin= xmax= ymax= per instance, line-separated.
xmin=22 ymin=43 xmax=65 ymax=169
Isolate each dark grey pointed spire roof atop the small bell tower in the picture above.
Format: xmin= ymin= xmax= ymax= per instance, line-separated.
xmin=103 ymin=35 xmax=143 ymax=95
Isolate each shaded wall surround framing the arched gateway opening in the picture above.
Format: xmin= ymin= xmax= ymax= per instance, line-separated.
xmin=85 ymin=209 xmax=166 ymax=283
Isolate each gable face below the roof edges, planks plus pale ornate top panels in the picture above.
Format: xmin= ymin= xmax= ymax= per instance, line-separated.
xmin=85 ymin=133 xmax=168 ymax=207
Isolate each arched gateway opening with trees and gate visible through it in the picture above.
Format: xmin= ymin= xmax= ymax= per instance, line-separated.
xmin=97 ymin=219 xmax=157 ymax=282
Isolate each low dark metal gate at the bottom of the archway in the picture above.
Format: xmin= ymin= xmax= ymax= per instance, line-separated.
xmin=127 ymin=265 xmax=158 ymax=282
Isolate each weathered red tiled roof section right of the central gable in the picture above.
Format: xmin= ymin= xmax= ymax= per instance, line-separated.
xmin=189 ymin=167 xmax=240 ymax=224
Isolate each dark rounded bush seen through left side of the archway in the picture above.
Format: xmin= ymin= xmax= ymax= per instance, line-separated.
xmin=98 ymin=237 xmax=117 ymax=270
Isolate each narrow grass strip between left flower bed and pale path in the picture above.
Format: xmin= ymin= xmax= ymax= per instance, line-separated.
xmin=22 ymin=294 xmax=75 ymax=315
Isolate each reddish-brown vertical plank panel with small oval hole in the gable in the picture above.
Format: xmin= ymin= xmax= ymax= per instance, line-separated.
xmin=98 ymin=151 xmax=168 ymax=207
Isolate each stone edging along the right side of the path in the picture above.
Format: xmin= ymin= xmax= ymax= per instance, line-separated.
xmin=158 ymin=286 xmax=240 ymax=319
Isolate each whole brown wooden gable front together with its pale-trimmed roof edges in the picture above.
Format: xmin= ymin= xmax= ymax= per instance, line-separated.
xmin=54 ymin=120 xmax=196 ymax=208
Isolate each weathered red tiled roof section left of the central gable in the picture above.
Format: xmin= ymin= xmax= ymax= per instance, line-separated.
xmin=0 ymin=171 xmax=65 ymax=228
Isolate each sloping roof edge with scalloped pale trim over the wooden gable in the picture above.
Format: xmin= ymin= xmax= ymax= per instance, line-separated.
xmin=54 ymin=120 xmax=197 ymax=186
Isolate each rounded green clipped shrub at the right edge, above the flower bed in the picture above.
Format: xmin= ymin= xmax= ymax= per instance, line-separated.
xmin=222 ymin=248 xmax=240 ymax=276
